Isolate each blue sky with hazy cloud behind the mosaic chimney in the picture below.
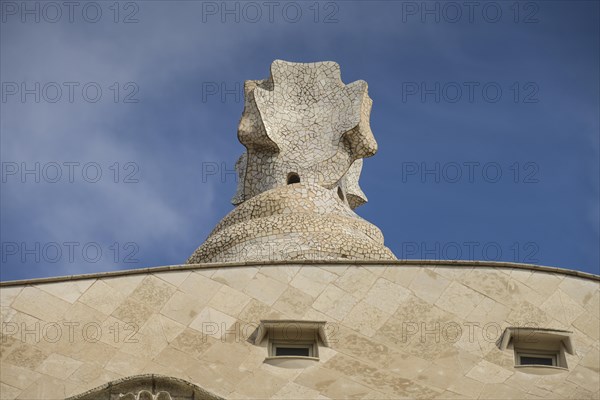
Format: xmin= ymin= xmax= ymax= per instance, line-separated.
xmin=0 ymin=1 xmax=600 ymax=280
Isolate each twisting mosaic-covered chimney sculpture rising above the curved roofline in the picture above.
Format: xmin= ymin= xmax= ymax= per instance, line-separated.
xmin=187 ymin=60 xmax=395 ymax=264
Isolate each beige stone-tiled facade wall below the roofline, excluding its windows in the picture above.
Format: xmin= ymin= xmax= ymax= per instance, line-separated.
xmin=0 ymin=261 xmax=600 ymax=400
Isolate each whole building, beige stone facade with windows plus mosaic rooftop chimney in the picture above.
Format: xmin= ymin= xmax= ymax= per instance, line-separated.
xmin=0 ymin=61 xmax=600 ymax=400
